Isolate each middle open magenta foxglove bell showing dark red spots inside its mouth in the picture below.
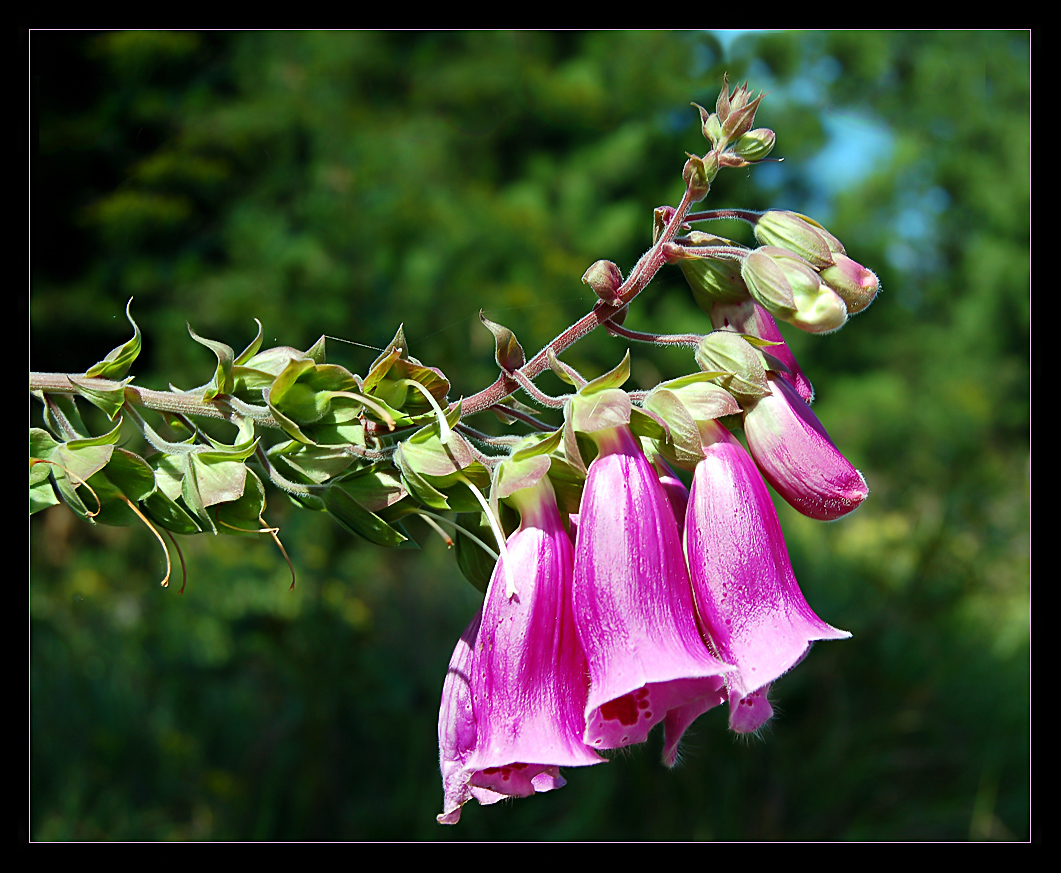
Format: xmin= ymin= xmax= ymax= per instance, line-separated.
xmin=574 ymin=426 xmax=732 ymax=761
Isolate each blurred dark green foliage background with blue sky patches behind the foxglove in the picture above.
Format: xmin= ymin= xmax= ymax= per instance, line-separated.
xmin=30 ymin=32 xmax=1030 ymax=840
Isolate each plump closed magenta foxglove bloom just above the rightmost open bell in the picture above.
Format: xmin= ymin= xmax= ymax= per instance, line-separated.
xmin=744 ymin=373 xmax=869 ymax=521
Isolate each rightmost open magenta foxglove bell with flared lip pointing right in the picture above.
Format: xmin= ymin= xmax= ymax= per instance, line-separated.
xmin=685 ymin=422 xmax=851 ymax=733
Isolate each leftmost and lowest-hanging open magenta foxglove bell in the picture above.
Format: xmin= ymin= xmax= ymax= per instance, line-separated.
xmin=439 ymin=478 xmax=604 ymax=824
